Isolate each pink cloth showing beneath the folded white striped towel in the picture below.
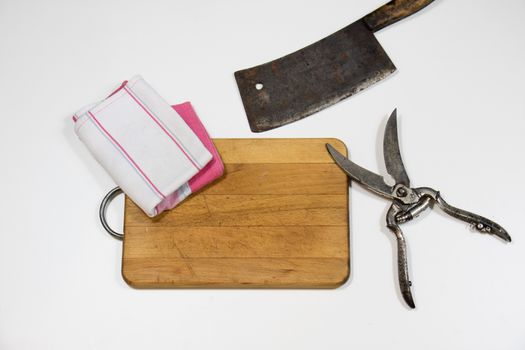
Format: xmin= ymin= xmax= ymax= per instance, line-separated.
xmin=152 ymin=102 xmax=224 ymax=213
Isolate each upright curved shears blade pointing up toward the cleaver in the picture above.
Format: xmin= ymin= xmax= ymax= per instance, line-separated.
xmin=383 ymin=109 xmax=410 ymax=187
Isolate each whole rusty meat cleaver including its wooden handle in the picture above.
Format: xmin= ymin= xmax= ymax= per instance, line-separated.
xmin=235 ymin=0 xmax=433 ymax=132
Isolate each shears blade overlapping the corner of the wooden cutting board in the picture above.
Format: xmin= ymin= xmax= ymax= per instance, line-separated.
xmin=326 ymin=143 xmax=394 ymax=199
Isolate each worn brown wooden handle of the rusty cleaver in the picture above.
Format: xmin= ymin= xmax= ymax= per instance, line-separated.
xmin=363 ymin=0 xmax=434 ymax=32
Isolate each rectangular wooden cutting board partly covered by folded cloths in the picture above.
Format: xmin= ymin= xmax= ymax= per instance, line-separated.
xmin=122 ymin=139 xmax=350 ymax=288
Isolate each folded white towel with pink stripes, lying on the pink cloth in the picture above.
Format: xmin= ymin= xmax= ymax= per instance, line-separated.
xmin=73 ymin=76 xmax=212 ymax=217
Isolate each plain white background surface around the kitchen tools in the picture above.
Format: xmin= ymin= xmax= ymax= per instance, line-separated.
xmin=0 ymin=0 xmax=525 ymax=350
